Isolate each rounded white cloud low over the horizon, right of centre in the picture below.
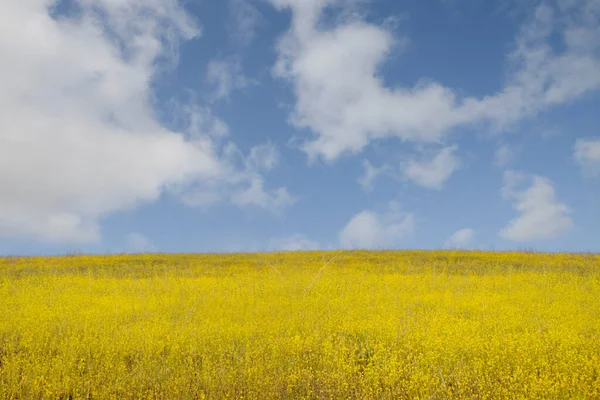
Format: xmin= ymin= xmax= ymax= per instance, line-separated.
xmin=340 ymin=206 xmax=415 ymax=249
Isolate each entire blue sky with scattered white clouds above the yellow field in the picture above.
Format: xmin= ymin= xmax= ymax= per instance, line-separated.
xmin=0 ymin=0 xmax=600 ymax=254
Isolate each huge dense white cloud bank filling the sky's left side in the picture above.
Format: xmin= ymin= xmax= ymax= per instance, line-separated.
xmin=0 ymin=0 xmax=290 ymax=242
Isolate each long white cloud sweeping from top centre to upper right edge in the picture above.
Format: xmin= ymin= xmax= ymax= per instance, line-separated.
xmin=271 ymin=0 xmax=600 ymax=161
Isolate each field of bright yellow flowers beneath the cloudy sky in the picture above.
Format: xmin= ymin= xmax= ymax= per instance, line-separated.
xmin=0 ymin=251 xmax=600 ymax=399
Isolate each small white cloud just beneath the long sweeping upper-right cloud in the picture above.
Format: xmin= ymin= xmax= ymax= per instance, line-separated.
xmin=402 ymin=146 xmax=460 ymax=190
